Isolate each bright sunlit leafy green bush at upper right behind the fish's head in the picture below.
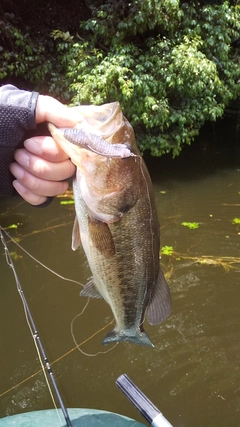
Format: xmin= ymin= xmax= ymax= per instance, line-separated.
xmin=64 ymin=0 xmax=240 ymax=155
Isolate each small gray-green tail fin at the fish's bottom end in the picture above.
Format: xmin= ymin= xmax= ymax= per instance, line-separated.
xmin=102 ymin=329 xmax=154 ymax=347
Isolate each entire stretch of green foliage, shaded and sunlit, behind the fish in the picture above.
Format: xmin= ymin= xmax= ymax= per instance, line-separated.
xmin=0 ymin=0 xmax=240 ymax=156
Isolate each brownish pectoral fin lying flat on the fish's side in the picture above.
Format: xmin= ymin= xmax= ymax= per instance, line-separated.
xmin=88 ymin=217 xmax=115 ymax=258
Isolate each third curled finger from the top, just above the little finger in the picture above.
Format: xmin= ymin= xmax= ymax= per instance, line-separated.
xmin=9 ymin=163 xmax=68 ymax=197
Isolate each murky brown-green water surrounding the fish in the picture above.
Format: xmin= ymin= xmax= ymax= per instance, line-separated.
xmin=0 ymin=118 xmax=240 ymax=427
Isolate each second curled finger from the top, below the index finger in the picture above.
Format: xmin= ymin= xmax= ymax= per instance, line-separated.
xmin=14 ymin=148 xmax=75 ymax=181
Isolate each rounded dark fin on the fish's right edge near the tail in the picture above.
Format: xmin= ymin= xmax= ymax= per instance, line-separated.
xmin=146 ymin=269 xmax=172 ymax=325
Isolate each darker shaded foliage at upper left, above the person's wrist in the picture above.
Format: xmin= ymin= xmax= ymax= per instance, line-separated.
xmin=0 ymin=13 xmax=72 ymax=100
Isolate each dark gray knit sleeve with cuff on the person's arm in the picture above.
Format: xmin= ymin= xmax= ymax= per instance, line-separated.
xmin=0 ymin=85 xmax=38 ymax=196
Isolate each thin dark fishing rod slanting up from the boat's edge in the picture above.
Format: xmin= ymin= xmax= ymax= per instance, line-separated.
xmin=0 ymin=226 xmax=72 ymax=427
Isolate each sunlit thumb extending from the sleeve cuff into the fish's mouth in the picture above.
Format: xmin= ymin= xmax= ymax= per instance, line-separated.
xmin=36 ymin=95 xmax=83 ymax=127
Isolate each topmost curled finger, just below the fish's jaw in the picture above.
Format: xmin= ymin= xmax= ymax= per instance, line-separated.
xmin=24 ymin=136 xmax=68 ymax=162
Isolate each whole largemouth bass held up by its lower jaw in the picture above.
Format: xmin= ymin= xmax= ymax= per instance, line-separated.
xmin=49 ymin=102 xmax=171 ymax=347
